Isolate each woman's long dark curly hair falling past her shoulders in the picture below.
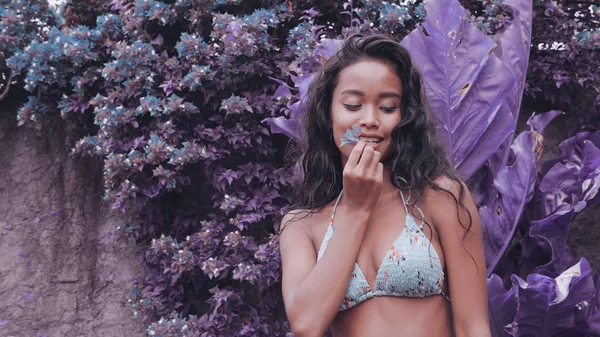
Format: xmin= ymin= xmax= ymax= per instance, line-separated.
xmin=282 ymin=34 xmax=472 ymax=249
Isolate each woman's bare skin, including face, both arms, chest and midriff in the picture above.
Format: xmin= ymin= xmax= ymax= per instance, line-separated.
xmin=280 ymin=59 xmax=491 ymax=337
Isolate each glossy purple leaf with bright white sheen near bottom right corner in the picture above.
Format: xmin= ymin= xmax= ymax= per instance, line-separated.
xmin=511 ymin=259 xmax=595 ymax=337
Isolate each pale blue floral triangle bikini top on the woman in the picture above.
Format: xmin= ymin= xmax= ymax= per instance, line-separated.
xmin=317 ymin=190 xmax=450 ymax=311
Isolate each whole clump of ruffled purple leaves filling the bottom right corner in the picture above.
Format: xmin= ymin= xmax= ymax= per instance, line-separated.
xmin=488 ymin=259 xmax=597 ymax=337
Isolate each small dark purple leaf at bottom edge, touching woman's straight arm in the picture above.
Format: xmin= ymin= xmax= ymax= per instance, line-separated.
xmin=487 ymin=274 xmax=518 ymax=337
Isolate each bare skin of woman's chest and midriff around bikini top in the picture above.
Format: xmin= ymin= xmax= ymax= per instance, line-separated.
xmin=310 ymin=188 xmax=452 ymax=337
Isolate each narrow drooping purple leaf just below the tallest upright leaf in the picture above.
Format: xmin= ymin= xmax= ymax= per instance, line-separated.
xmin=479 ymin=111 xmax=558 ymax=276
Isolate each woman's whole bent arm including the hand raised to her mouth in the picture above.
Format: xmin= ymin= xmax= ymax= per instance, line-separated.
xmin=279 ymin=140 xmax=383 ymax=337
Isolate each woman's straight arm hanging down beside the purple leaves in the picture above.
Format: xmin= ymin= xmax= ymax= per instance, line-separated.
xmin=425 ymin=177 xmax=491 ymax=337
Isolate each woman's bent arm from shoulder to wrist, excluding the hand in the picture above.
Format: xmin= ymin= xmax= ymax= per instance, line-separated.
xmin=280 ymin=207 xmax=370 ymax=337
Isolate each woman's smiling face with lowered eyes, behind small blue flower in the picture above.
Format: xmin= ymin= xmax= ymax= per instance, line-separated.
xmin=331 ymin=59 xmax=402 ymax=166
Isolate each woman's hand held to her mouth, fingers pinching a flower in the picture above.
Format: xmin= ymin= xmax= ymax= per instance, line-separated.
xmin=342 ymin=140 xmax=383 ymax=213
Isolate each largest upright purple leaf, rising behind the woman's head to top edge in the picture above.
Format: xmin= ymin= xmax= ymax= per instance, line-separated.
xmin=401 ymin=0 xmax=515 ymax=178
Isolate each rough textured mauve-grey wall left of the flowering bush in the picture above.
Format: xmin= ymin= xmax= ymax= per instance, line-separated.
xmin=0 ymin=108 xmax=145 ymax=337
